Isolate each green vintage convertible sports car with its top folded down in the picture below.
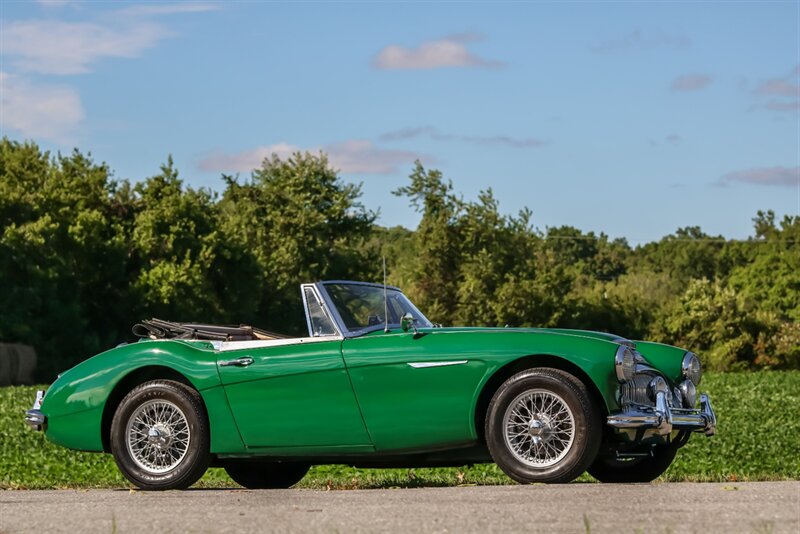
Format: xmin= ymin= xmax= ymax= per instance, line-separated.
xmin=25 ymin=281 xmax=716 ymax=490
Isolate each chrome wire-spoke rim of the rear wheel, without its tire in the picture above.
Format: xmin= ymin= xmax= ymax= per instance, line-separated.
xmin=125 ymin=399 xmax=192 ymax=474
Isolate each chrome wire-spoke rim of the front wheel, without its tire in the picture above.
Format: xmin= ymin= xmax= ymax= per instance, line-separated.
xmin=503 ymin=389 xmax=575 ymax=467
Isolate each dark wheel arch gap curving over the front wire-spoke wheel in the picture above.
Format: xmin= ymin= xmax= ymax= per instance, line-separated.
xmin=472 ymin=354 xmax=608 ymax=443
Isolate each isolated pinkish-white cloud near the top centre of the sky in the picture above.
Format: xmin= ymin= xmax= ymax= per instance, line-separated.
xmin=372 ymin=33 xmax=503 ymax=70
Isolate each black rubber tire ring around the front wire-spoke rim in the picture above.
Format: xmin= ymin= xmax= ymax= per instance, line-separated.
xmin=486 ymin=369 xmax=600 ymax=483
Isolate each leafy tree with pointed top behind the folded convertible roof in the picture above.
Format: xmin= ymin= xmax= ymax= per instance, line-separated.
xmin=129 ymin=157 xmax=261 ymax=323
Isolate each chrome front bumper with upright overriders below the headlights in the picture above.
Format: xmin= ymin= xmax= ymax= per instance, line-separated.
xmin=607 ymin=393 xmax=717 ymax=436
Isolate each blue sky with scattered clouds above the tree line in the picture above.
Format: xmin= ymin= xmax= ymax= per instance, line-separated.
xmin=0 ymin=0 xmax=800 ymax=244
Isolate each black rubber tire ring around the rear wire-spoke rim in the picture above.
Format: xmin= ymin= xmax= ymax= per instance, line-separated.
xmin=110 ymin=381 xmax=209 ymax=490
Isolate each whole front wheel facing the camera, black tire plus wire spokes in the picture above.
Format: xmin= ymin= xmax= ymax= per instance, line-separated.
xmin=486 ymin=367 xmax=602 ymax=484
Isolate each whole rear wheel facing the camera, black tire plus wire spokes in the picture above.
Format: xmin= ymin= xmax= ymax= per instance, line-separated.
xmin=110 ymin=380 xmax=211 ymax=490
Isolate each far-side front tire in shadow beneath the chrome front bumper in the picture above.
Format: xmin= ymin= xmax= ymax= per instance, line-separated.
xmin=589 ymin=444 xmax=679 ymax=483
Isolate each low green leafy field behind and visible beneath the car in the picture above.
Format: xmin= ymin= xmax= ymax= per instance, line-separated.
xmin=0 ymin=371 xmax=800 ymax=489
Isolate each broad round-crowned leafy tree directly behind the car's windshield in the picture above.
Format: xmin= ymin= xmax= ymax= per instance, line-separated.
xmin=220 ymin=152 xmax=377 ymax=334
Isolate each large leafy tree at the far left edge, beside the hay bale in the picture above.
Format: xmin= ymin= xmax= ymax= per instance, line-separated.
xmin=0 ymin=138 xmax=126 ymax=377
